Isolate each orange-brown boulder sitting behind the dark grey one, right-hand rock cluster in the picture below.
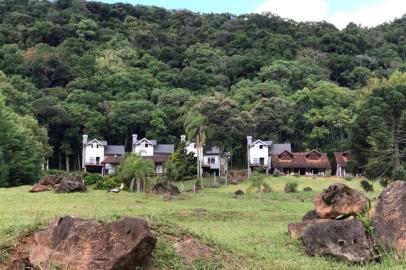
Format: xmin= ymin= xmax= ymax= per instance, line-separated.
xmin=314 ymin=184 xmax=369 ymax=219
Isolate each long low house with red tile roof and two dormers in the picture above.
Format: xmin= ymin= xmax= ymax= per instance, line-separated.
xmin=272 ymin=150 xmax=331 ymax=176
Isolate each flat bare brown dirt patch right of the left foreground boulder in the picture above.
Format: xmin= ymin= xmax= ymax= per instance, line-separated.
xmin=173 ymin=236 xmax=215 ymax=263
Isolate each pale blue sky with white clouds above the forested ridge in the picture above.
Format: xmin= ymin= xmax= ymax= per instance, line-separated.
xmin=102 ymin=0 xmax=406 ymax=29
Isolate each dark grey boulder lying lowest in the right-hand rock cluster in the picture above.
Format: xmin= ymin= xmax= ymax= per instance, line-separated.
xmin=302 ymin=220 xmax=378 ymax=264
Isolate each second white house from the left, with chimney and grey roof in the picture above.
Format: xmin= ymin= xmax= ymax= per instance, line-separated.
xmin=131 ymin=134 xmax=175 ymax=175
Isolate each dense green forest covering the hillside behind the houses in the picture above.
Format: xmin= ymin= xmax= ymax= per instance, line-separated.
xmin=0 ymin=0 xmax=406 ymax=185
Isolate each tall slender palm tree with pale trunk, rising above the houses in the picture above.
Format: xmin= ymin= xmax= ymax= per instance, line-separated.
xmin=185 ymin=112 xmax=210 ymax=180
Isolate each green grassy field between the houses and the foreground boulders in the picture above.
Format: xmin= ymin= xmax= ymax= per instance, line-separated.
xmin=0 ymin=177 xmax=406 ymax=269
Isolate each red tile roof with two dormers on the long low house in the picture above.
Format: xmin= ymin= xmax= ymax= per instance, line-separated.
xmin=272 ymin=150 xmax=331 ymax=169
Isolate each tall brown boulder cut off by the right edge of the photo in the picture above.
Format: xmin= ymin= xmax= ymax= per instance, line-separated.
xmin=371 ymin=181 xmax=406 ymax=255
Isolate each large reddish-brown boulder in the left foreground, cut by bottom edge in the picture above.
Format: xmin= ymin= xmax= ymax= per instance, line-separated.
xmin=28 ymin=216 xmax=156 ymax=270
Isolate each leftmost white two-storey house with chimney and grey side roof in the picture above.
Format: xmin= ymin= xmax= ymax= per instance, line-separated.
xmin=82 ymin=134 xmax=125 ymax=175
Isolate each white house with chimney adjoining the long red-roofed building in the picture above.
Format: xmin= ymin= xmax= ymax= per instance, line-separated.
xmin=247 ymin=136 xmax=292 ymax=175
